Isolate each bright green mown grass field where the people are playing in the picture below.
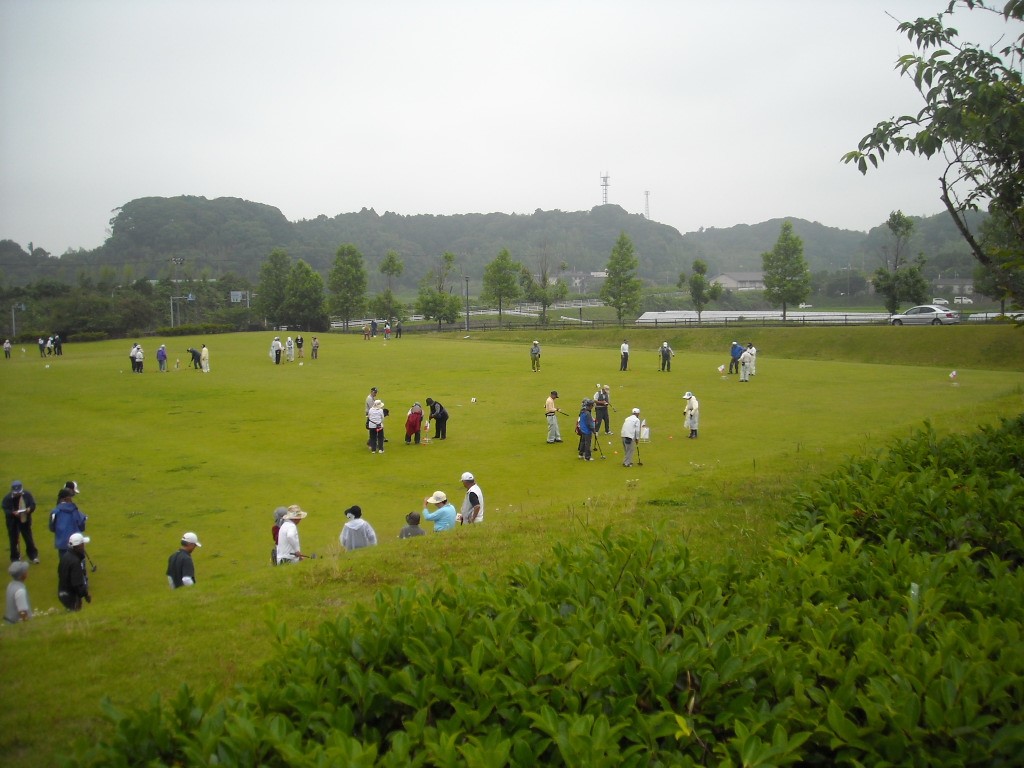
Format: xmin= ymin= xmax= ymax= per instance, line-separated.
xmin=0 ymin=326 xmax=1024 ymax=766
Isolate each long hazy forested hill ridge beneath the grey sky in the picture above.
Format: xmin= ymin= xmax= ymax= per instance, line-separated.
xmin=0 ymin=197 xmax=966 ymax=290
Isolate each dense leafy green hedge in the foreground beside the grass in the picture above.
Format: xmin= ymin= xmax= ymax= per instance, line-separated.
xmin=70 ymin=419 xmax=1024 ymax=766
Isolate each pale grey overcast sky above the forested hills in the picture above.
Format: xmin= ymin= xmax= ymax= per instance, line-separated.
xmin=0 ymin=0 xmax=1004 ymax=254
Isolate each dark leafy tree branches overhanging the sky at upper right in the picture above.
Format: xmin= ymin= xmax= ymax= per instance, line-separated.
xmin=843 ymin=0 xmax=1024 ymax=304
